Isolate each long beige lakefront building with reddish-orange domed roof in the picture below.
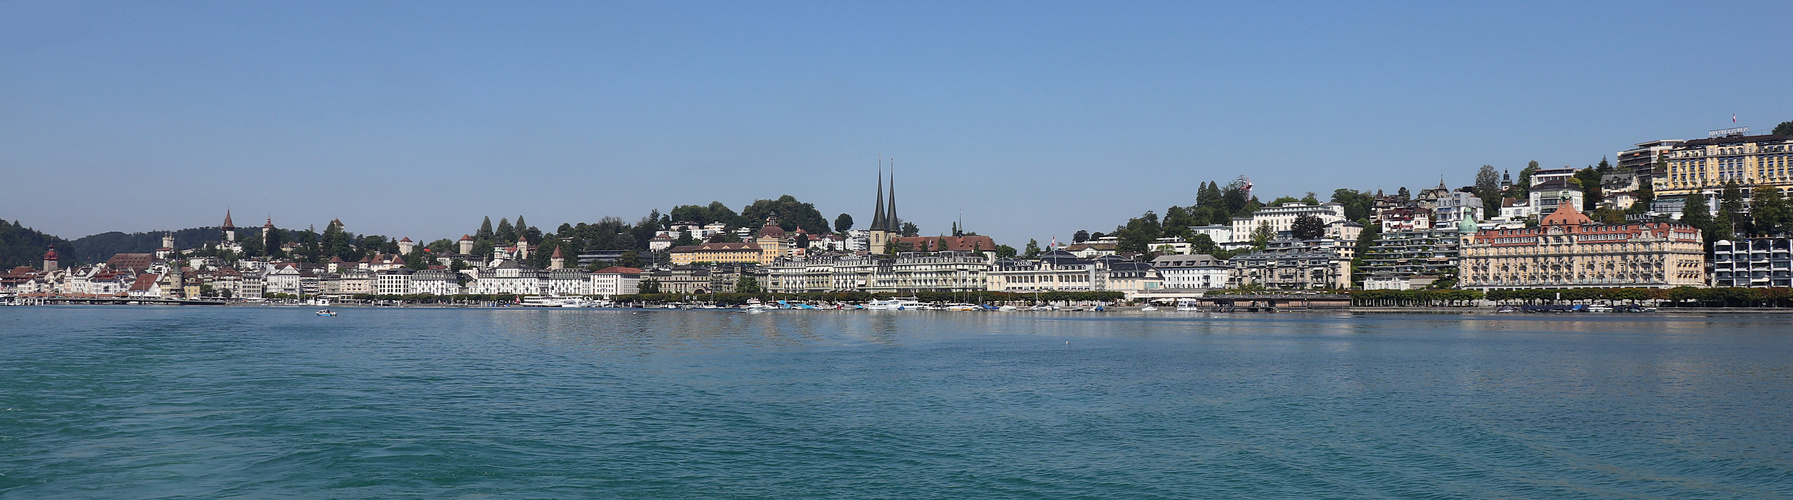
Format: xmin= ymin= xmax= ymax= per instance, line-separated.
xmin=1458 ymin=203 xmax=1705 ymax=290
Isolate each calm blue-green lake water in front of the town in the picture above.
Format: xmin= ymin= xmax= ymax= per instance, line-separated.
xmin=0 ymin=306 xmax=1793 ymax=498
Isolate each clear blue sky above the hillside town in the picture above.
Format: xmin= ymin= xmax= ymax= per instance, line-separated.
xmin=0 ymin=0 xmax=1793 ymax=247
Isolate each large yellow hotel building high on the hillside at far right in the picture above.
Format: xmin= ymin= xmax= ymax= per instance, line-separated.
xmin=1653 ymin=133 xmax=1793 ymax=197
